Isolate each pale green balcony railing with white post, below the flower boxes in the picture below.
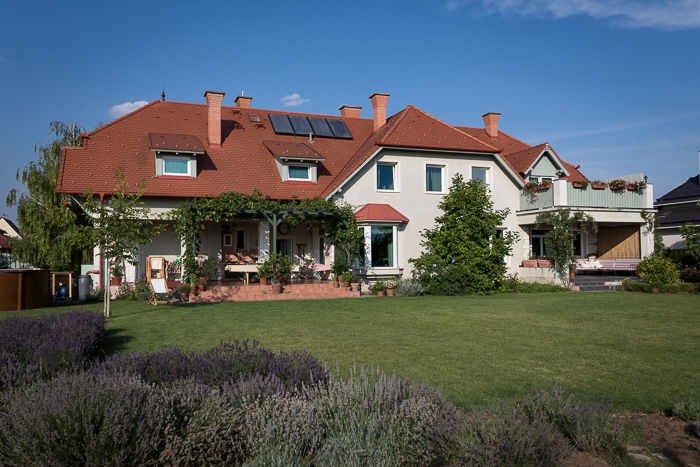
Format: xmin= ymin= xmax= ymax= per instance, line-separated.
xmin=520 ymin=180 xmax=654 ymax=211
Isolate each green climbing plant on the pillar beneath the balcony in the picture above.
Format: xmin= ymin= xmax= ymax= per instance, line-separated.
xmin=535 ymin=209 xmax=598 ymax=284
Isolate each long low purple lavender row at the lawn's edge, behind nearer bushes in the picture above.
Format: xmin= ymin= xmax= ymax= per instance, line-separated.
xmin=93 ymin=341 xmax=328 ymax=387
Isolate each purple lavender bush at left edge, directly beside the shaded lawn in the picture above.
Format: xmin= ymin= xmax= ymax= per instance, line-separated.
xmin=0 ymin=311 xmax=105 ymax=390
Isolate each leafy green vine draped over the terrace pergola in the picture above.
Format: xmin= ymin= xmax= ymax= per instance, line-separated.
xmin=170 ymin=191 xmax=362 ymax=283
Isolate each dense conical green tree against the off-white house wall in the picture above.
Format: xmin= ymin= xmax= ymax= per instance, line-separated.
xmin=410 ymin=174 xmax=518 ymax=294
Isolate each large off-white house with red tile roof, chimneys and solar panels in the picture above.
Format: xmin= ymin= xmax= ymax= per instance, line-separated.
xmin=58 ymin=91 xmax=653 ymax=280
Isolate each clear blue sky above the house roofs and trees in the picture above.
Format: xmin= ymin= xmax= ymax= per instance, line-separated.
xmin=0 ymin=0 xmax=700 ymax=218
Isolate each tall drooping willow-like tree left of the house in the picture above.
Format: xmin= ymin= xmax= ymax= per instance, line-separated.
xmin=6 ymin=122 xmax=87 ymax=272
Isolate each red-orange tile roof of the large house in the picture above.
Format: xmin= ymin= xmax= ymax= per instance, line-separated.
xmin=57 ymin=101 xmax=585 ymax=199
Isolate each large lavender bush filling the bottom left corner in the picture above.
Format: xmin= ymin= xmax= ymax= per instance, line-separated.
xmin=0 ymin=373 xmax=168 ymax=465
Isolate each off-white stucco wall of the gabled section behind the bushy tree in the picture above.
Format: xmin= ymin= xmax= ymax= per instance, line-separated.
xmin=335 ymin=149 xmax=528 ymax=274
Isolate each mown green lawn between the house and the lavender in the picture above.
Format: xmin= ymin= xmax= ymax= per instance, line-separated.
xmin=0 ymin=292 xmax=700 ymax=411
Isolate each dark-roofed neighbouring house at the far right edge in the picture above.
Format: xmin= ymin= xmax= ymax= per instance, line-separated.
xmin=654 ymin=152 xmax=700 ymax=249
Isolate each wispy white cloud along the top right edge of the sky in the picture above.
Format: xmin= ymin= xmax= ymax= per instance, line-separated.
xmin=445 ymin=0 xmax=700 ymax=30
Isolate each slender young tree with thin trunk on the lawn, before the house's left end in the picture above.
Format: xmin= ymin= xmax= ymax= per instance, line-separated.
xmin=82 ymin=169 xmax=160 ymax=318
